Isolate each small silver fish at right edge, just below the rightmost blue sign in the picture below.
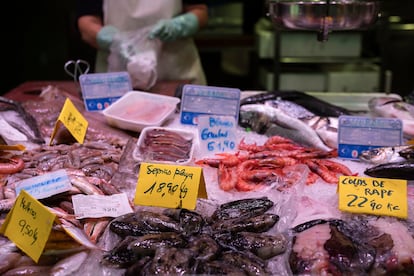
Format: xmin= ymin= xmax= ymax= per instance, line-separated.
xmin=358 ymin=145 xmax=414 ymax=164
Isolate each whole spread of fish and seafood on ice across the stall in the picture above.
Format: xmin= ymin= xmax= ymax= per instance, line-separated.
xmin=0 ymin=82 xmax=414 ymax=275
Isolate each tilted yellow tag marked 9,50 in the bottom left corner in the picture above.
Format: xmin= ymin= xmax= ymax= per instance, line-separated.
xmin=0 ymin=190 xmax=56 ymax=262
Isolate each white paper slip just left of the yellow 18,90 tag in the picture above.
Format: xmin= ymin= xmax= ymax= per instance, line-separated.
xmin=72 ymin=193 xmax=133 ymax=219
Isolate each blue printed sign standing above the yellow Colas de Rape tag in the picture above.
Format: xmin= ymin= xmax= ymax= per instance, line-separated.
xmin=338 ymin=115 xmax=403 ymax=159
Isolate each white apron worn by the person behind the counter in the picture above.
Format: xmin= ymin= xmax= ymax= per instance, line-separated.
xmin=95 ymin=0 xmax=206 ymax=85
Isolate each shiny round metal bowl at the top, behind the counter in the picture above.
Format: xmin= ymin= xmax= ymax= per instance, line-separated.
xmin=269 ymin=0 xmax=379 ymax=33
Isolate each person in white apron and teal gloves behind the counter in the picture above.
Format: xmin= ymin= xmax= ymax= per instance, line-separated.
xmin=77 ymin=0 xmax=208 ymax=88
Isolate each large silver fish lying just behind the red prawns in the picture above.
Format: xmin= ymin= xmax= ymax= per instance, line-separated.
xmin=239 ymin=104 xmax=331 ymax=151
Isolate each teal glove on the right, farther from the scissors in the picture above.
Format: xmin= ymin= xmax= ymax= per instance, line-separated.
xmin=149 ymin=12 xmax=199 ymax=41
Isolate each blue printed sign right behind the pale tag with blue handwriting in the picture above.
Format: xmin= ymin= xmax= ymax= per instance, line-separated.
xmin=180 ymin=84 xmax=241 ymax=125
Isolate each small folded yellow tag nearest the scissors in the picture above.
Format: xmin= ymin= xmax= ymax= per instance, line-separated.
xmin=50 ymin=98 xmax=88 ymax=144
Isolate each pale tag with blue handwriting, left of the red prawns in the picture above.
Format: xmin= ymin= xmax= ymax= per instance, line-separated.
xmin=197 ymin=115 xmax=237 ymax=156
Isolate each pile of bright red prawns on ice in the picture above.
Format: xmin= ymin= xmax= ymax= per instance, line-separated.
xmin=195 ymin=135 xmax=356 ymax=192
